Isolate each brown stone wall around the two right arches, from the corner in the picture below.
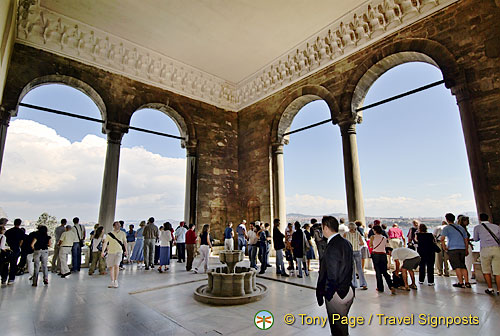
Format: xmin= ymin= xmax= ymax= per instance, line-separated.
xmin=238 ymin=0 xmax=500 ymax=222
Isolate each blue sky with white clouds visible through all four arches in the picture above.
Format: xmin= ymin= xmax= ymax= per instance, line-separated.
xmin=0 ymin=63 xmax=475 ymax=222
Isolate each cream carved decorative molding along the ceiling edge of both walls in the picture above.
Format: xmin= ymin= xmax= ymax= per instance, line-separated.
xmin=16 ymin=0 xmax=458 ymax=111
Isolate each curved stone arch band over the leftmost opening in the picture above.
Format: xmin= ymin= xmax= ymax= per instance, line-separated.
xmin=14 ymin=75 xmax=107 ymax=121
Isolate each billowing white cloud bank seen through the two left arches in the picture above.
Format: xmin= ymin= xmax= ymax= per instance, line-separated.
xmin=0 ymin=119 xmax=186 ymax=221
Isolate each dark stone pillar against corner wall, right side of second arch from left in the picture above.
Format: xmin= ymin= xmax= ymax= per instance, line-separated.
xmin=184 ymin=146 xmax=198 ymax=225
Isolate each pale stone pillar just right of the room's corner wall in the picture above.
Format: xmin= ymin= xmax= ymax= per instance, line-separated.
xmin=271 ymin=143 xmax=287 ymax=232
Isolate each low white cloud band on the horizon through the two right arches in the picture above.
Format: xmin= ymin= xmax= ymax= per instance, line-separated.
xmin=286 ymin=194 xmax=475 ymax=217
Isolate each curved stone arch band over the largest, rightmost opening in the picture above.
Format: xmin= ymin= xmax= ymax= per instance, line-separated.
xmin=340 ymin=38 xmax=461 ymax=122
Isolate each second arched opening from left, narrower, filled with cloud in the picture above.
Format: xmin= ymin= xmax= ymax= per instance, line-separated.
xmin=116 ymin=105 xmax=187 ymax=228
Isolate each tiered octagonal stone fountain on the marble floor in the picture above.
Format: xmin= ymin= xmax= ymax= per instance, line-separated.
xmin=194 ymin=250 xmax=267 ymax=305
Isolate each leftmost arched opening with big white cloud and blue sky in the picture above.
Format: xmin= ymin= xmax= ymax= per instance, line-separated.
xmin=0 ymin=83 xmax=106 ymax=226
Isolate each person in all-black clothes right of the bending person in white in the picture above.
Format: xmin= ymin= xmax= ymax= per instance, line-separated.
xmin=415 ymin=224 xmax=441 ymax=286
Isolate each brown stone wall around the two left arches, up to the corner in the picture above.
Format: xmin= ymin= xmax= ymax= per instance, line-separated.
xmin=1 ymin=44 xmax=240 ymax=238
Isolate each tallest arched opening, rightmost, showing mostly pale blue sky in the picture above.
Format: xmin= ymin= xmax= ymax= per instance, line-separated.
xmin=352 ymin=60 xmax=476 ymax=227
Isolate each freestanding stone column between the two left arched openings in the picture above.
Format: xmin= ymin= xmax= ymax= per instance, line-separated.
xmin=99 ymin=129 xmax=124 ymax=232
